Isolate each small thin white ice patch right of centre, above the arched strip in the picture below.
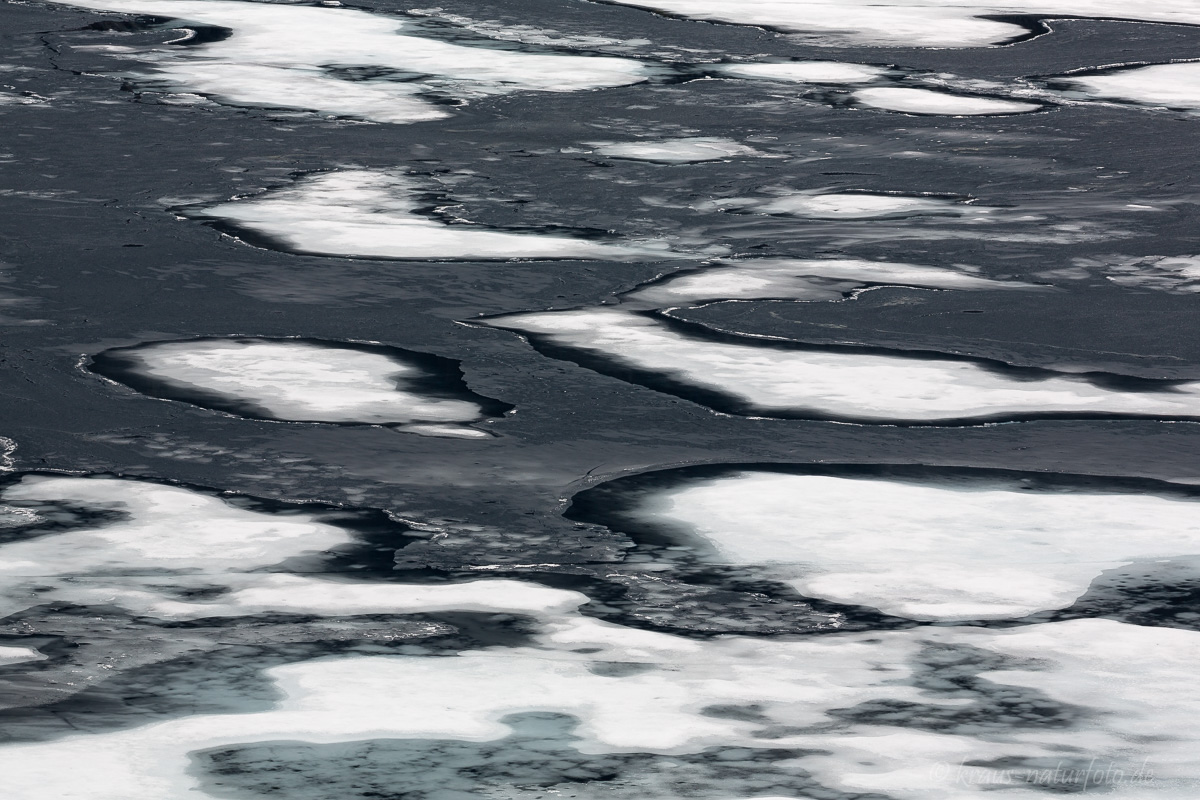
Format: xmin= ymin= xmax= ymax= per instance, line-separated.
xmin=713 ymin=192 xmax=990 ymax=219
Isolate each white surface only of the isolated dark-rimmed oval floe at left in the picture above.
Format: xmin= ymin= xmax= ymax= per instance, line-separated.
xmin=111 ymin=339 xmax=484 ymax=425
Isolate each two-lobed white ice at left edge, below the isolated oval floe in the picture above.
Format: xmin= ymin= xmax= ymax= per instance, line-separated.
xmin=0 ymin=476 xmax=587 ymax=619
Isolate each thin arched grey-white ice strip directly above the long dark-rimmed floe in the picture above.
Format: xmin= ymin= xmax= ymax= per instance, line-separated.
xmin=622 ymin=258 xmax=1037 ymax=308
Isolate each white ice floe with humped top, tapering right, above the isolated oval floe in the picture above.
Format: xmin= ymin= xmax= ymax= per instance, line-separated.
xmin=184 ymin=169 xmax=678 ymax=261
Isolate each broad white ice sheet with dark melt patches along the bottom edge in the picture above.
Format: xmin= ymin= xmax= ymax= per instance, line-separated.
xmin=0 ymin=618 xmax=1200 ymax=800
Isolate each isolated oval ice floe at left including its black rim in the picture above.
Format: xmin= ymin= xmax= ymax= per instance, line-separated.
xmin=90 ymin=338 xmax=512 ymax=433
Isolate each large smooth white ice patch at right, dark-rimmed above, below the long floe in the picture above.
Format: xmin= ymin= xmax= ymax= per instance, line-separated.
xmin=637 ymin=471 xmax=1200 ymax=619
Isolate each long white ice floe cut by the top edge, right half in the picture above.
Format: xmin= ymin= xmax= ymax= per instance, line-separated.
xmin=585 ymin=0 xmax=1200 ymax=47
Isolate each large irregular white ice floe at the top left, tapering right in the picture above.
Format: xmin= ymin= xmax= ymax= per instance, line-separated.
xmin=46 ymin=0 xmax=649 ymax=122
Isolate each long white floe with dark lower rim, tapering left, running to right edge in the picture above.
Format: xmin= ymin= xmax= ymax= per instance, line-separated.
xmin=488 ymin=309 xmax=1200 ymax=423
